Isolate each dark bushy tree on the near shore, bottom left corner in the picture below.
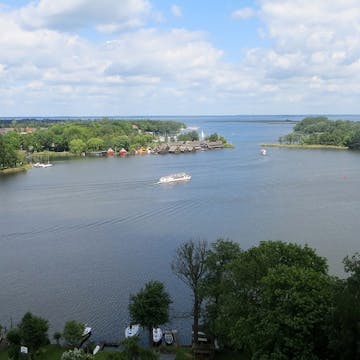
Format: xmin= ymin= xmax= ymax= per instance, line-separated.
xmin=19 ymin=312 xmax=49 ymax=359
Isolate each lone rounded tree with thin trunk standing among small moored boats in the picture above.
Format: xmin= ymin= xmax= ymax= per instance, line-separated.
xmin=129 ymin=281 xmax=172 ymax=344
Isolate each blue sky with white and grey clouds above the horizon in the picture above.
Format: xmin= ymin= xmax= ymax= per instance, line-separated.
xmin=0 ymin=0 xmax=360 ymax=117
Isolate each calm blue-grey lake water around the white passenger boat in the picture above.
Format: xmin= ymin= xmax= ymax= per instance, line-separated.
xmin=0 ymin=118 xmax=360 ymax=341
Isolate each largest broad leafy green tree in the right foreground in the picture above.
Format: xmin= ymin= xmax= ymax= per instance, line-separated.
xmin=215 ymin=241 xmax=332 ymax=359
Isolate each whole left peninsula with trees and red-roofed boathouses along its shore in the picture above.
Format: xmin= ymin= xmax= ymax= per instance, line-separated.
xmin=0 ymin=118 xmax=231 ymax=174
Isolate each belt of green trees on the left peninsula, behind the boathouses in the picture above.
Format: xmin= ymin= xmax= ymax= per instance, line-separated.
xmin=0 ymin=119 xmax=186 ymax=155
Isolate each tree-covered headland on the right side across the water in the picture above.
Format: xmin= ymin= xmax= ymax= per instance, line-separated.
xmin=279 ymin=116 xmax=360 ymax=149
